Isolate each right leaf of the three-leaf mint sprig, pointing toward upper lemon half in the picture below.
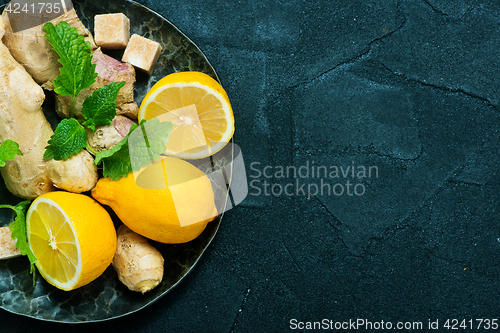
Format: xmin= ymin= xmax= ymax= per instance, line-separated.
xmin=82 ymin=81 xmax=125 ymax=132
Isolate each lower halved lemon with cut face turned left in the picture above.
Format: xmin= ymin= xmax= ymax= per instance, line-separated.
xmin=26 ymin=191 xmax=116 ymax=290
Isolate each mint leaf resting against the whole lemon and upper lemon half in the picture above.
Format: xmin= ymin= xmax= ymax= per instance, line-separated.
xmin=94 ymin=118 xmax=172 ymax=180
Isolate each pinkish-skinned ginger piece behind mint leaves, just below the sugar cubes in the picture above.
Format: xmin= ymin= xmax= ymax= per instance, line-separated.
xmin=56 ymin=49 xmax=139 ymax=119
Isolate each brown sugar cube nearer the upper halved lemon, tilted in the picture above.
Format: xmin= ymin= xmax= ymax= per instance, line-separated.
xmin=122 ymin=34 xmax=161 ymax=74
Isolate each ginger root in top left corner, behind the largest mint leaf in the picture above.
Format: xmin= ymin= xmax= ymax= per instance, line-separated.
xmin=2 ymin=8 xmax=96 ymax=90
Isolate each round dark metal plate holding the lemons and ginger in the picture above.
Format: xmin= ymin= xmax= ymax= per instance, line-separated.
xmin=0 ymin=0 xmax=229 ymax=323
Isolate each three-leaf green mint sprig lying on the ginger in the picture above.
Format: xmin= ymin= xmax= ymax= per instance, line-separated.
xmin=43 ymin=21 xmax=125 ymax=160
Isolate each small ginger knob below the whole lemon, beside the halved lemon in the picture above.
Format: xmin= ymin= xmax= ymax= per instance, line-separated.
xmin=113 ymin=225 xmax=163 ymax=294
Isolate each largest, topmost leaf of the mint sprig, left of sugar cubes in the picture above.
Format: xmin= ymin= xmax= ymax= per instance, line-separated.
xmin=43 ymin=21 xmax=97 ymax=100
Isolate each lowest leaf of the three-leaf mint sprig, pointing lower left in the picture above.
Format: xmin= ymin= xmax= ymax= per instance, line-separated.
xmin=43 ymin=118 xmax=87 ymax=160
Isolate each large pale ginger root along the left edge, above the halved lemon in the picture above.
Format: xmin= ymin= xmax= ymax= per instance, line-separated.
xmin=0 ymin=41 xmax=97 ymax=200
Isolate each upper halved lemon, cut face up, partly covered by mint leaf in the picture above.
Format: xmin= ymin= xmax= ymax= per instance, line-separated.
xmin=138 ymin=72 xmax=234 ymax=159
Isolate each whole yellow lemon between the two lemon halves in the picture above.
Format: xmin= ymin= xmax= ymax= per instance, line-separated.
xmin=92 ymin=157 xmax=218 ymax=244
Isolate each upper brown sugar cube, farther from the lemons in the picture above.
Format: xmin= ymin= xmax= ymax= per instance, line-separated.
xmin=94 ymin=13 xmax=130 ymax=50
